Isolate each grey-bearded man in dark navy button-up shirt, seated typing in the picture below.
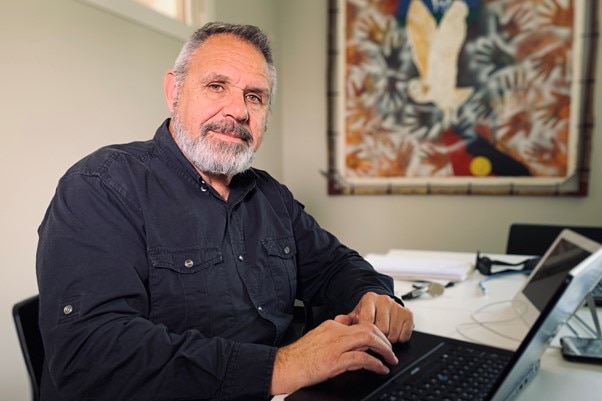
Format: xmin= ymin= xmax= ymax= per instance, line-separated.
xmin=37 ymin=23 xmax=413 ymax=401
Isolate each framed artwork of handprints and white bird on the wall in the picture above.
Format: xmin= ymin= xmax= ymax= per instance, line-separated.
xmin=325 ymin=0 xmax=598 ymax=196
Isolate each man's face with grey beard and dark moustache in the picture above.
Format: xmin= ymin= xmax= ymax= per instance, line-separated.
xmin=166 ymin=34 xmax=271 ymax=176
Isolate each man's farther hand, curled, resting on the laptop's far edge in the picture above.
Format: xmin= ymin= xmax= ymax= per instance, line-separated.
xmin=334 ymin=292 xmax=414 ymax=343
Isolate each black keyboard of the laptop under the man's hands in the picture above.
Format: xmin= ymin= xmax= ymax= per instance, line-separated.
xmin=371 ymin=343 xmax=510 ymax=401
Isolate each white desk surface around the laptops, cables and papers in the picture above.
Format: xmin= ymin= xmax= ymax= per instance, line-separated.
xmin=392 ymin=250 xmax=602 ymax=401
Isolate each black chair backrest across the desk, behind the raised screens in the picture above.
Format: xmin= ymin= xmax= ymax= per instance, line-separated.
xmin=506 ymin=223 xmax=602 ymax=256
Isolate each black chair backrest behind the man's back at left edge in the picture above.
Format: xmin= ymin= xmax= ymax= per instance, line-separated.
xmin=13 ymin=295 xmax=44 ymax=401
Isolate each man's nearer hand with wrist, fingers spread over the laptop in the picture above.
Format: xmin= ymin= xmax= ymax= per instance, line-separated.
xmin=270 ymin=318 xmax=398 ymax=395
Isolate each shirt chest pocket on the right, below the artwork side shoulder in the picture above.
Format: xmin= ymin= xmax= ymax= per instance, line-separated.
xmin=261 ymin=236 xmax=297 ymax=312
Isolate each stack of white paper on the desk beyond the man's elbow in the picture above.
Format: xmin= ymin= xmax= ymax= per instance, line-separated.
xmin=366 ymin=254 xmax=472 ymax=281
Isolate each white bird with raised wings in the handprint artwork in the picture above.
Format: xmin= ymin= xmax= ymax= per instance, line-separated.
xmin=406 ymin=0 xmax=473 ymax=127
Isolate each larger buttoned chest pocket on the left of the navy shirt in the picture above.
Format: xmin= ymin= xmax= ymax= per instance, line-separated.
xmin=149 ymin=247 xmax=225 ymax=332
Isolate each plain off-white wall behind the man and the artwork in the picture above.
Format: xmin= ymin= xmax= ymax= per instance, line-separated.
xmin=0 ymin=0 xmax=602 ymax=401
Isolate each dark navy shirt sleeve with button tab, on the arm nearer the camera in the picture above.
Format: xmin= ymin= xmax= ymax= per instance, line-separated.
xmin=37 ymin=174 xmax=276 ymax=401
